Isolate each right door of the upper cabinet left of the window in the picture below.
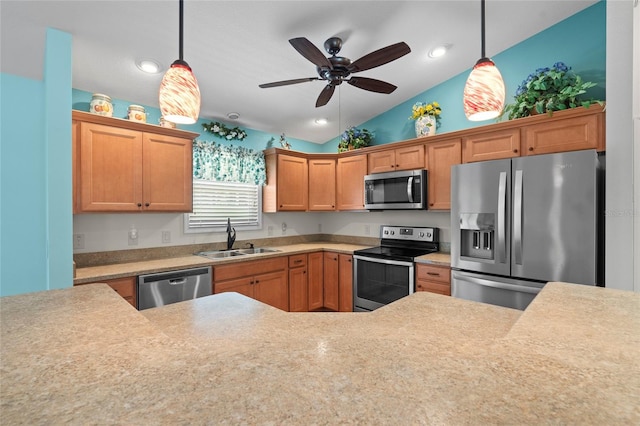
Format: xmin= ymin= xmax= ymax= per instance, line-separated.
xmin=142 ymin=133 xmax=193 ymax=212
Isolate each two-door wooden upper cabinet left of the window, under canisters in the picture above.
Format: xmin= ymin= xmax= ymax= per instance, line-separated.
xmin=72 ymin=111 xmax=197 ymax=213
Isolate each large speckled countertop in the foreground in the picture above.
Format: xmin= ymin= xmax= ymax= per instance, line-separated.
xmin=0 ymin=283 xmax=640 ymax=425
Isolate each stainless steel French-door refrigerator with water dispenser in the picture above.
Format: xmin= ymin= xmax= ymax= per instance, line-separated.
xmin=451 ymin=150 xmax=604 ymax=309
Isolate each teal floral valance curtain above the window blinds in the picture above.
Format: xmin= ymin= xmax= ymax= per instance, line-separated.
xmin=193 ymin=140 xmax=266 ymax=185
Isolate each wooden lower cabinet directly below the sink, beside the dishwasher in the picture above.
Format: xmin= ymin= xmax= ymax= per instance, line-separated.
xmin=213 ymin=256 xmax=289 ymax=311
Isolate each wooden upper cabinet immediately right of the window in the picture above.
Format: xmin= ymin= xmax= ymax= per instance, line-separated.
xmin=262 ymin=152 xmax=309 ymax=213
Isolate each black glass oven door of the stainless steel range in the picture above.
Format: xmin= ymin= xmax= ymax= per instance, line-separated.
xmin=353 ymin=255 xmax=414 ymax=311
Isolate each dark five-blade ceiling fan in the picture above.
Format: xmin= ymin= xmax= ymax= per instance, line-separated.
xmin=259 ymin=37 xmax=411 ymax=108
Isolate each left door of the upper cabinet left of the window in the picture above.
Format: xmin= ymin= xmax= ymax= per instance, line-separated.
xmin=79 ymin=123 xmax=142 ymax=212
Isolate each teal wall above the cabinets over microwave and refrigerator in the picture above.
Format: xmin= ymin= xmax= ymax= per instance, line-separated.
xmin=324 ymin=1 xmax=606 ymax=152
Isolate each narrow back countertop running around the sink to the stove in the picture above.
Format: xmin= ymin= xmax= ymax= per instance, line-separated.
xmin=73 ymin=243 xmax=368 ymax=284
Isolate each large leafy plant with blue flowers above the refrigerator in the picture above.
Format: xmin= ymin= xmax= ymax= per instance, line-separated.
xmin=503 ymin=62 xmax=602 ymax=120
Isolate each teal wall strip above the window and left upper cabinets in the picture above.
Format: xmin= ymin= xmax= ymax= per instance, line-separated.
xmin=72 ymin=89 xmax=324 ymax=152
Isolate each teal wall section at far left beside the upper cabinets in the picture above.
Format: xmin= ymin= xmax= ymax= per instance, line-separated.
xmin=0 ymin=30 xmax=73 ymax=296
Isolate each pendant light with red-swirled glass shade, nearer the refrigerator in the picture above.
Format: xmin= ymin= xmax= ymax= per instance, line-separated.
xmin=463 ymin=0 xmax=505 ymax=121
